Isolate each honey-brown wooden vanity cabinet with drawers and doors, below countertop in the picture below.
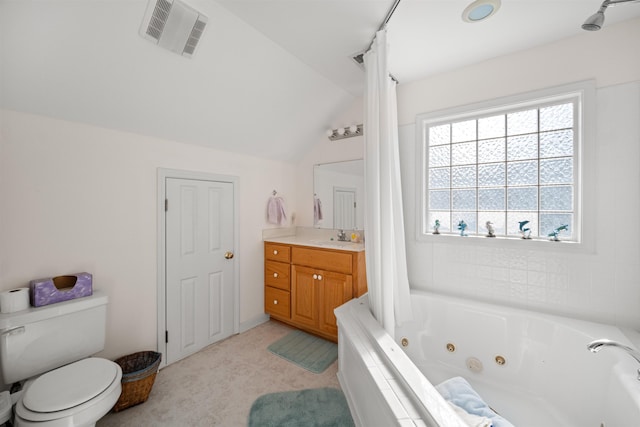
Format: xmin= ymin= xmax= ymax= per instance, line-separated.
xmin=265 ymin=242 xmax=367 ymax=341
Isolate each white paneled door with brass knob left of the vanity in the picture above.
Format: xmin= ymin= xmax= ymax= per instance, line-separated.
xmin=165 ymin=178 xmax=235 ymax=364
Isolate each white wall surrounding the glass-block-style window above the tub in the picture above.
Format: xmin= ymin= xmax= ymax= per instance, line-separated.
xmin=398 ymin=20 xmax=640 ymax=328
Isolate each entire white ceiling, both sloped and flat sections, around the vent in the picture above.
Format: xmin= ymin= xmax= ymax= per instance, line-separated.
xmin=0 ymin=0 xmax=640 ymax=161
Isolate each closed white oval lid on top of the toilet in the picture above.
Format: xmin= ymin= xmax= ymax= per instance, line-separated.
xmin=22 ymin=357 xmax=118 ymax=412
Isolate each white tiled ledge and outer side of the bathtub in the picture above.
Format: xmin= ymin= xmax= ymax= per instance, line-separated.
xmin=335 ymin=294 xmax=467 ymax=427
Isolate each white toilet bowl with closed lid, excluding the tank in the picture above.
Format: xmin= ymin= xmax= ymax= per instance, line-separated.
xmin=14 ymin=357 xmax=122 ymax=427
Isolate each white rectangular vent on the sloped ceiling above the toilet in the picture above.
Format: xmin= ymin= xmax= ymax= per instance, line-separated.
xmin=140 ymin=0 xmax=208 ymax=57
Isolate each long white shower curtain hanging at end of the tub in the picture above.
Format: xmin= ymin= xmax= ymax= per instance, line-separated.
xmin=364 ymin=29 xmax=412 ymax=336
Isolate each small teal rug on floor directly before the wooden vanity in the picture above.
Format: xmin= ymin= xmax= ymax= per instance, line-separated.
xmin=268 ymin=330 xmax=338 ymax=374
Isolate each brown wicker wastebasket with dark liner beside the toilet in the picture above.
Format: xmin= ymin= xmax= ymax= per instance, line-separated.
xmin=113 ymin=351 xmax=162 ymax=412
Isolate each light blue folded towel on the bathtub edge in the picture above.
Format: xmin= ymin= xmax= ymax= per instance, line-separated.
xmin=436 ymin=377 xmax=514 ymax=427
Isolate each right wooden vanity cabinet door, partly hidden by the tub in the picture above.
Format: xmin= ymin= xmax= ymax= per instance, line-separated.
xmin=318 ymin=271 xmax=353 ymax=336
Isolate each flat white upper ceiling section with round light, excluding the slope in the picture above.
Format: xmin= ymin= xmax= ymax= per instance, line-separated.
xmin=218 ymin=0 xmax=640 ymax=96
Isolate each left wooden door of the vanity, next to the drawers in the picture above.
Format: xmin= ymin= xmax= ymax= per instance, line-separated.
xmin=291 ymin=265 xmax=318 ymax=328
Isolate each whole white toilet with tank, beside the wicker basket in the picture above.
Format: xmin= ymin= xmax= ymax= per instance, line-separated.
xmin=0 ymin=291 xmax=122 ymax=427
